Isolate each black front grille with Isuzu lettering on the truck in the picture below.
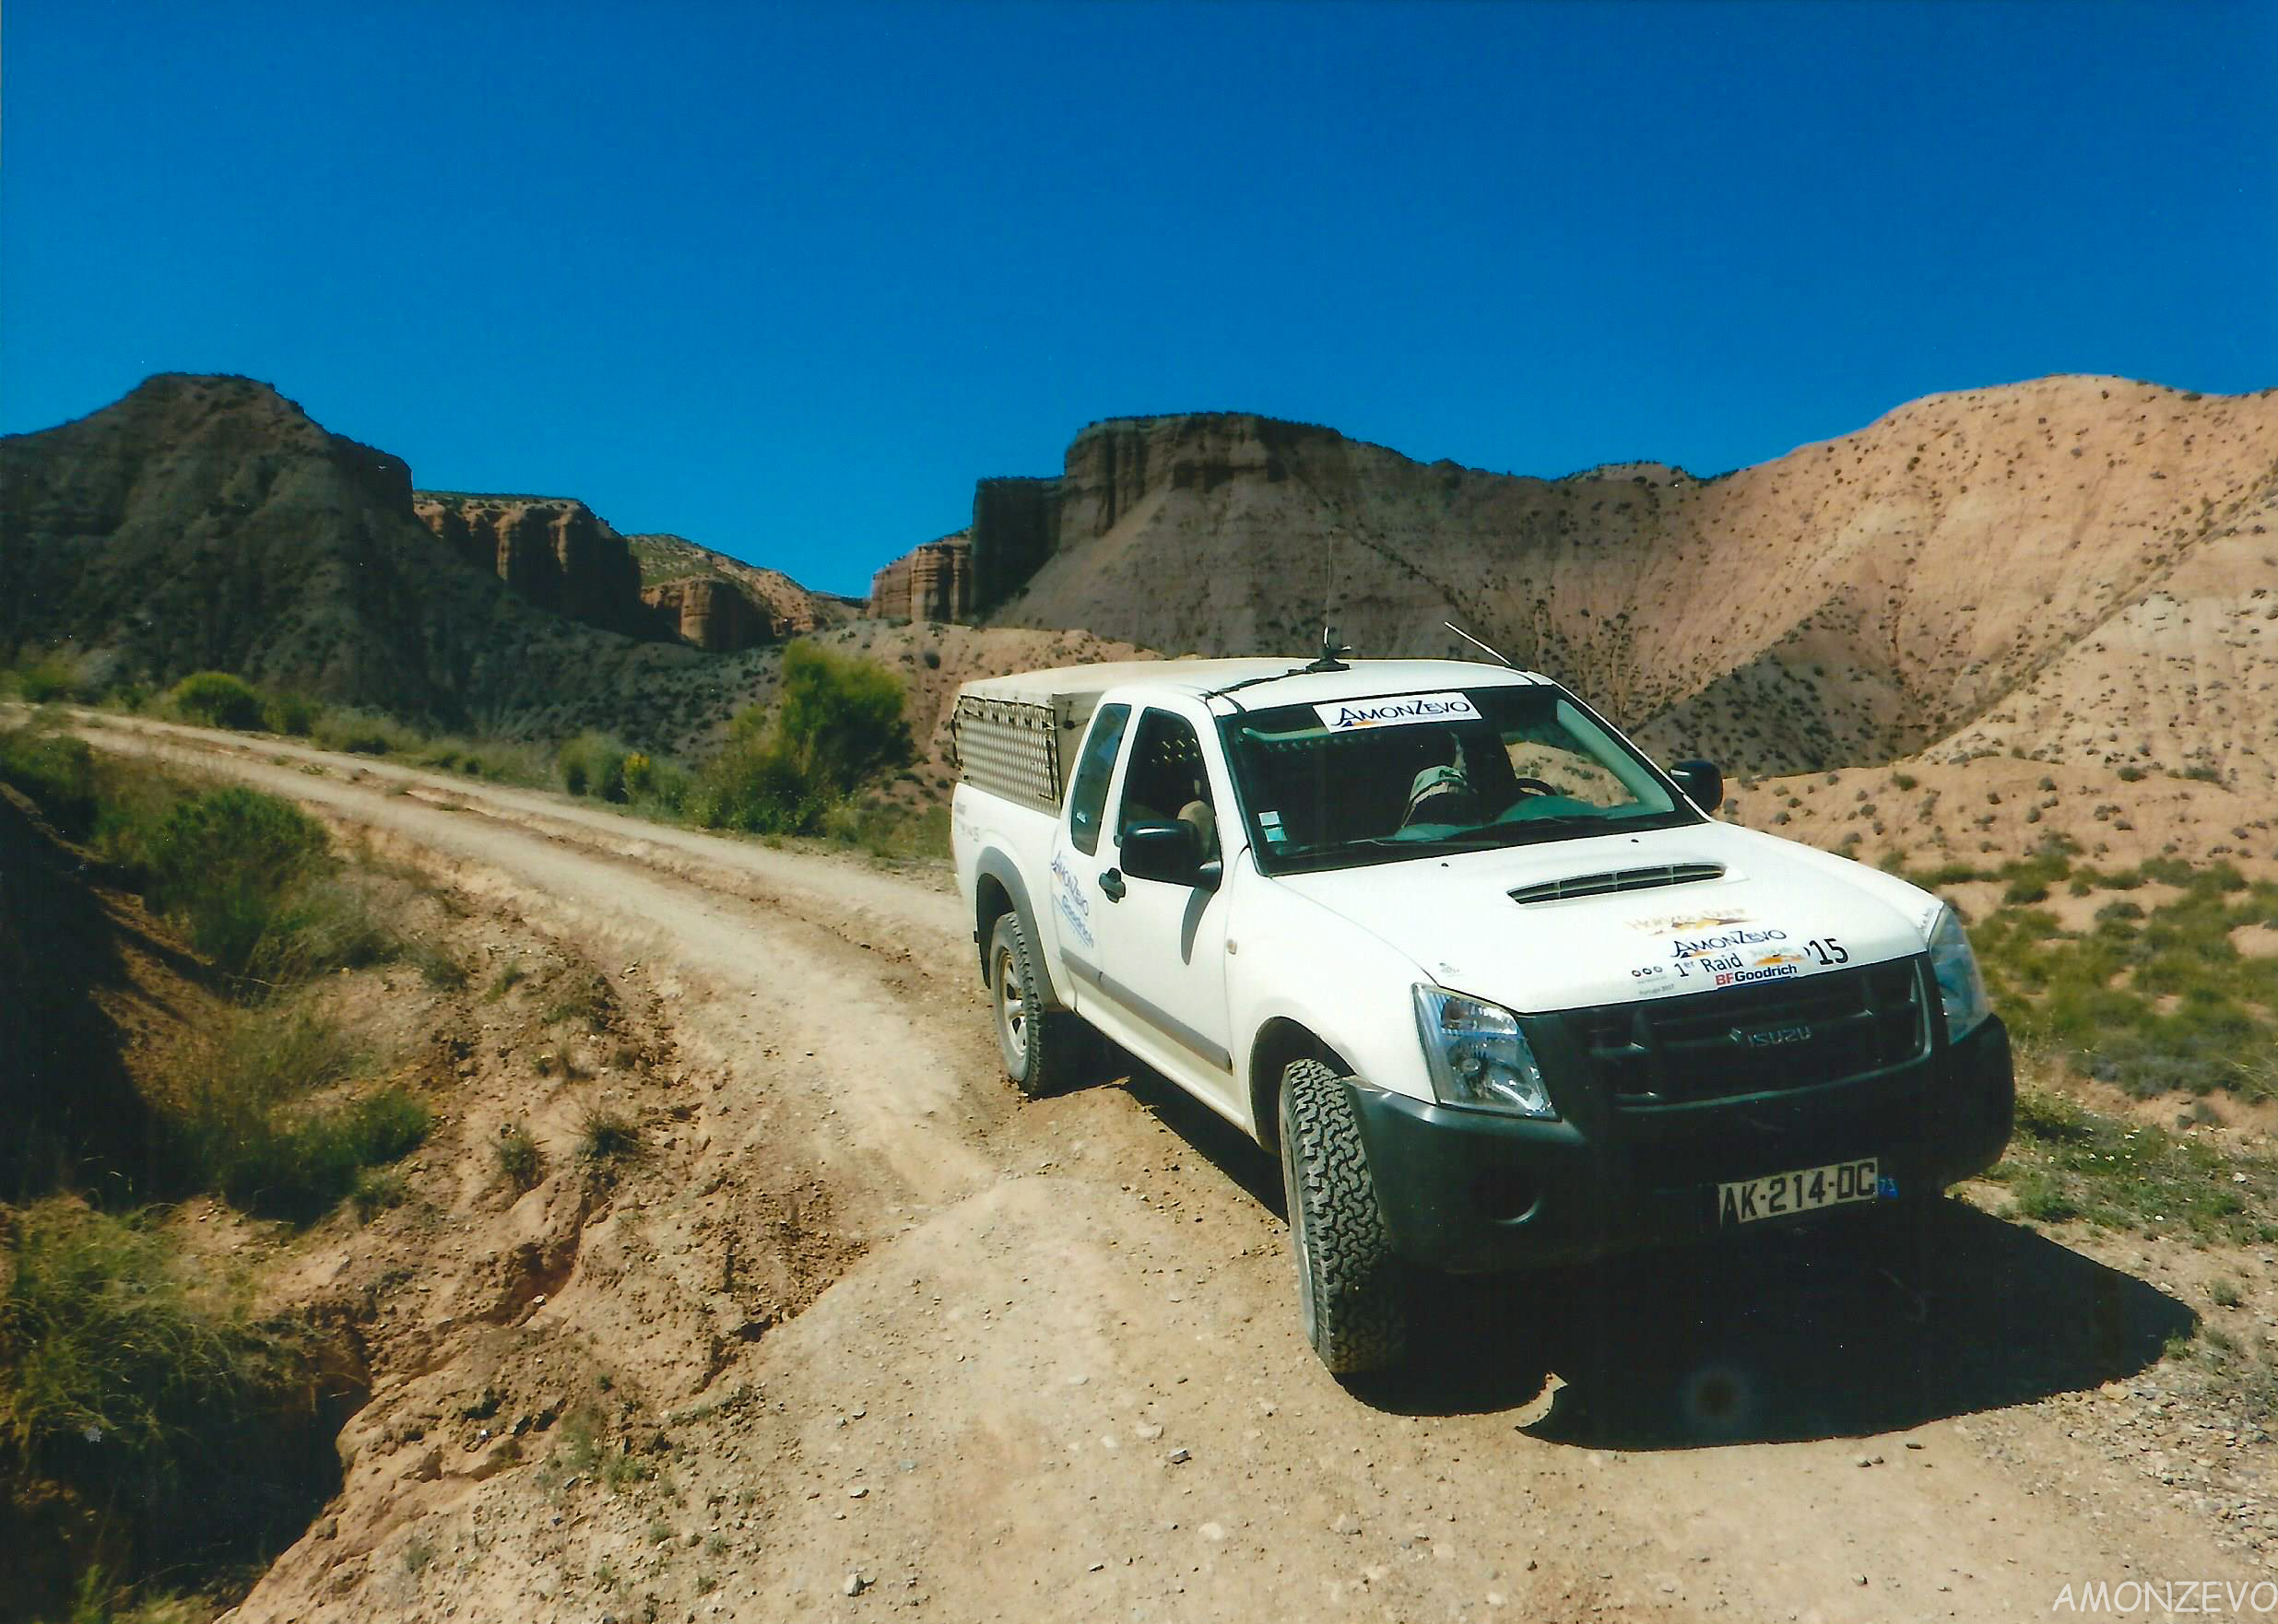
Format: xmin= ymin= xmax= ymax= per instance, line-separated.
xmin=1565 ymin=959 xmax=1930 ymax=1109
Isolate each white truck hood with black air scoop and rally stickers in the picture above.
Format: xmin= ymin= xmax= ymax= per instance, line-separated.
xmin=1278 ymin=822 xmax=1939 ymax=1011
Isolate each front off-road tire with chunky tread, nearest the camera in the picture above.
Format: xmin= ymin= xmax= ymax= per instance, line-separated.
xmin=1281 ymin=1059 xmax=1408 ymax=1376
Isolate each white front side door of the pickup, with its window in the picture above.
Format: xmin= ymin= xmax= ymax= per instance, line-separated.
xmin=1070 ymin=709 xmax=1242 ymax=1109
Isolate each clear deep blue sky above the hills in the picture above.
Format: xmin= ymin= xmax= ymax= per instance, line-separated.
xmin=0 ymin=0 xmax=2278 ymax=593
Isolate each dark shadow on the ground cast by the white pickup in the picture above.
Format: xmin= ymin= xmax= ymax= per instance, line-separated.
xmin=1123 ymin=1066 xmax=2199 ymax=1449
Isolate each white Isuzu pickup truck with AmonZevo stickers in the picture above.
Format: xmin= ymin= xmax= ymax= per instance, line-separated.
xmin=952 ymin=656 xmax=2013 ymax=1373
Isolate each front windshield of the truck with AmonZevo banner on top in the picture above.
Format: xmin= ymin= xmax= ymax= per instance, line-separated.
xmin=1219 ymin=686 xmax=1699 ymax=872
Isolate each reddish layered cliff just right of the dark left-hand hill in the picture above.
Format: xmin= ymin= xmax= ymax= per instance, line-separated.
xmin=412 ymin=489 xmax=656 ymax=638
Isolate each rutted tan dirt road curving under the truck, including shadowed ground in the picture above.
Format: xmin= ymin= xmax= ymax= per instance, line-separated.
xmin=76 ymin=720 xmax=2267 ymax=1622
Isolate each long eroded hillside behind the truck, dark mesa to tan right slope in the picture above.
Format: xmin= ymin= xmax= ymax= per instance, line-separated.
xmin=881 ymin=378 xmax=2278 ymax=783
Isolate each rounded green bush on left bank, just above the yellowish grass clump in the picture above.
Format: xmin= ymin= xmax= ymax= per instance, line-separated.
xmin=148 ymin=786 xmax=330 ymax=975
